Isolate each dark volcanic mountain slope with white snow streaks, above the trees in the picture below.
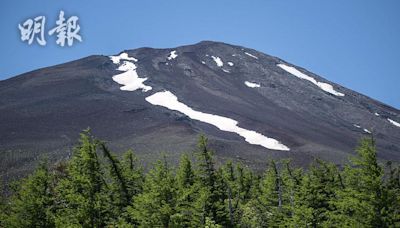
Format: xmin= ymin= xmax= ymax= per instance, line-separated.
xmin=0 ymin=41 xmax=400 ymax=179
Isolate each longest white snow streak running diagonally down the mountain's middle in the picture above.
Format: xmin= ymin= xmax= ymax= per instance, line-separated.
xmin=146 ymin=91 xmax=290 ymax=151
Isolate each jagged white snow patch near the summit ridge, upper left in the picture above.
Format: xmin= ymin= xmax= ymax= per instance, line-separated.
xmin=110 ymin=53 xmax=152 ymax=92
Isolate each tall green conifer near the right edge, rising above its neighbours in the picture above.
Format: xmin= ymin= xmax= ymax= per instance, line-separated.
xmin=330 ymin=138 xmax=392 ymax=227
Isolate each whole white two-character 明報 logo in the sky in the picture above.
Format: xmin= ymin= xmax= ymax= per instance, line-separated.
xmin=18 ymin=11 xmax=82 ymax=47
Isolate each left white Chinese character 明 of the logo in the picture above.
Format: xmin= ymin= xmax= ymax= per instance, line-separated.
xmin=18 ymin=16 xmax=46 ymax=46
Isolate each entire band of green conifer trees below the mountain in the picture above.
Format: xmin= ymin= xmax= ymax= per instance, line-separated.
xmin=0 ymin=131 xmax=400 ymax=227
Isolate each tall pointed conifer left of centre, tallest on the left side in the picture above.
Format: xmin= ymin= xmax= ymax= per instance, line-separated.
xmin=56 ymin=130 xmax=112 ymax=227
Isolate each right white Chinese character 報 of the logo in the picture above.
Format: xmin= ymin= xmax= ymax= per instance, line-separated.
xmin=49 ymin=11 xmax=82 ymax=47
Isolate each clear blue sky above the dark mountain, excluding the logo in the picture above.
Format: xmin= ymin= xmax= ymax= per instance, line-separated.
xmin=0 ymin=0 xmax=400 ymax=109
